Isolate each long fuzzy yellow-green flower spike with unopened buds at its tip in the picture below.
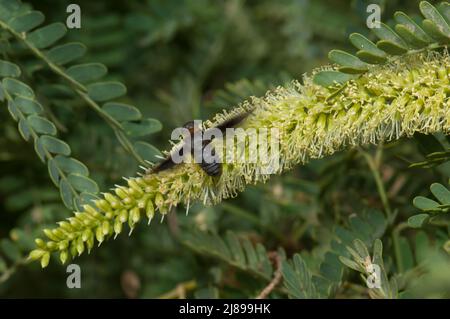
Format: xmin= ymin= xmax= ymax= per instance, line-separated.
xmin=30 ymin=52 xmax=450 ymax=267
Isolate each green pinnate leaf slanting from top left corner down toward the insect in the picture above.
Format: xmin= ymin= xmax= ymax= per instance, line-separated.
xmin=0 ymin=0 xmax=161 ymax=165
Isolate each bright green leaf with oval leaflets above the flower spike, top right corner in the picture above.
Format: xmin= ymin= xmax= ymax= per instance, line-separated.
xmin=314 ymin=1 xmax=450 ymax=87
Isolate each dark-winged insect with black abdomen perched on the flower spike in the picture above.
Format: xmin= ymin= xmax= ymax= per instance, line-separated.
xmin=151 ymin=110 xmax=252 ymax=176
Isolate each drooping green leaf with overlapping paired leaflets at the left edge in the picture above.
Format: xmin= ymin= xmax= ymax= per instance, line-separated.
xmin=0 ymin=61 xmax=99 ymax=210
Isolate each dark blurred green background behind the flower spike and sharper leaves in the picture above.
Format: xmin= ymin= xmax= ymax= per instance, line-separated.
xmin=0 ymin=0 xmax=450 ymax=298
